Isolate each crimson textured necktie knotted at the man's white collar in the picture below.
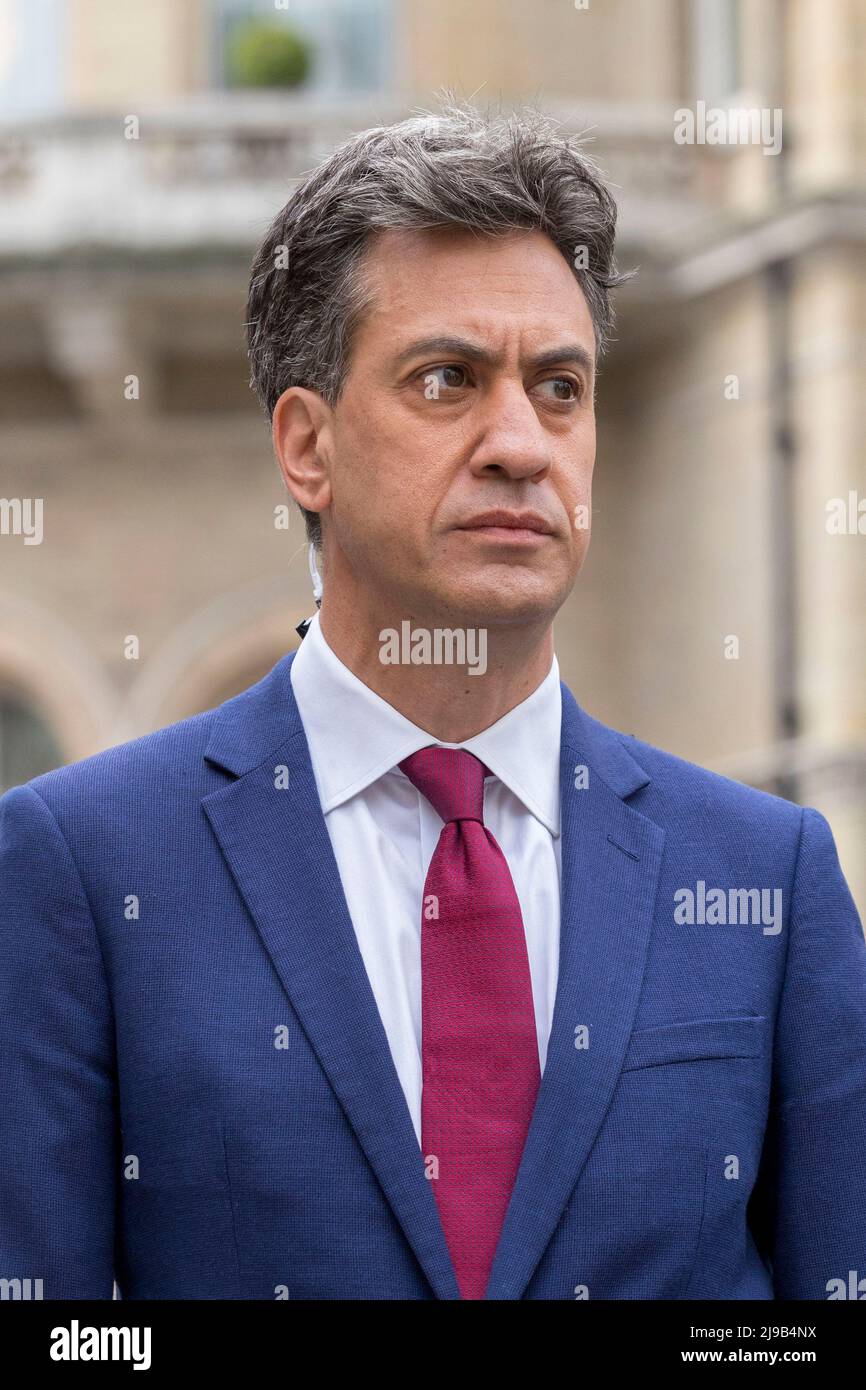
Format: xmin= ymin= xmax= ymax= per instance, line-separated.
xmin=399 ymin=745 xmax=541 ymax=1298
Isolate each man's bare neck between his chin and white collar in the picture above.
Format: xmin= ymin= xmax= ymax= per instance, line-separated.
xmin=318 ymin=585 xmax=553 ymax=744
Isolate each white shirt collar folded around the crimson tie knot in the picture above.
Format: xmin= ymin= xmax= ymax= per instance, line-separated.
xmin=291 ymin=613 xmax=562 ymax=835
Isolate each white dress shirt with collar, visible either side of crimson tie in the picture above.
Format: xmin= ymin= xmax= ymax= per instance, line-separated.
xmin=292 ymin=614 xmax=562 ymax=1145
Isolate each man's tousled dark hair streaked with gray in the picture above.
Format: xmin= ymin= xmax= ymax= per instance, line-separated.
xmin=246 ymin=99 xmax=628 ymax=548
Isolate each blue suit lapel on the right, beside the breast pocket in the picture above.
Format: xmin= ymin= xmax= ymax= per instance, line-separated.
xmin=487 ymin=685 xmax=664 ymax=1298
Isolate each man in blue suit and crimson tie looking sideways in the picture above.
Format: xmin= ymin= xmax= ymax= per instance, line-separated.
xmin=0 ymin=107 xmax=866 ymax=1300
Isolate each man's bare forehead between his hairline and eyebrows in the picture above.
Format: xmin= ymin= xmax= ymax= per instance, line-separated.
xmin=359 ymin=228 xmax=595 ymax=350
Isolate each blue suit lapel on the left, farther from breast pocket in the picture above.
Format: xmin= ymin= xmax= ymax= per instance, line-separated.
xmin=202 ymin=655 xmax=459 ymax=1298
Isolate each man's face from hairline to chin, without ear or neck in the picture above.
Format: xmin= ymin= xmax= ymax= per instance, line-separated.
xmin=318 ymin=229 xmax=595 ymax=626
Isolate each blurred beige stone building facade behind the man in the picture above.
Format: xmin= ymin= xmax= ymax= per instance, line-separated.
xmin=0 ymin=0 xmax=866 ymax=910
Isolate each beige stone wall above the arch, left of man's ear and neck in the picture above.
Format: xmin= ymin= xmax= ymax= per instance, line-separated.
xmin=0 ymin=386 xmax=311 ymax=759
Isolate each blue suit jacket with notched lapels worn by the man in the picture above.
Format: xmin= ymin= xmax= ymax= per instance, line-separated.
xmin=0 ymin=655 xmax=866 ymax=1300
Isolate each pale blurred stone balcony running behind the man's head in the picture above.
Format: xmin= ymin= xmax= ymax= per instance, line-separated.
xmin=0 ymin=95 xmax=724 ymax=261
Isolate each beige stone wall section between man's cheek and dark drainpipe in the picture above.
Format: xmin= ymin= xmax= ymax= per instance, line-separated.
xmin=558 ymin=282 xmax=773 ymax=762
